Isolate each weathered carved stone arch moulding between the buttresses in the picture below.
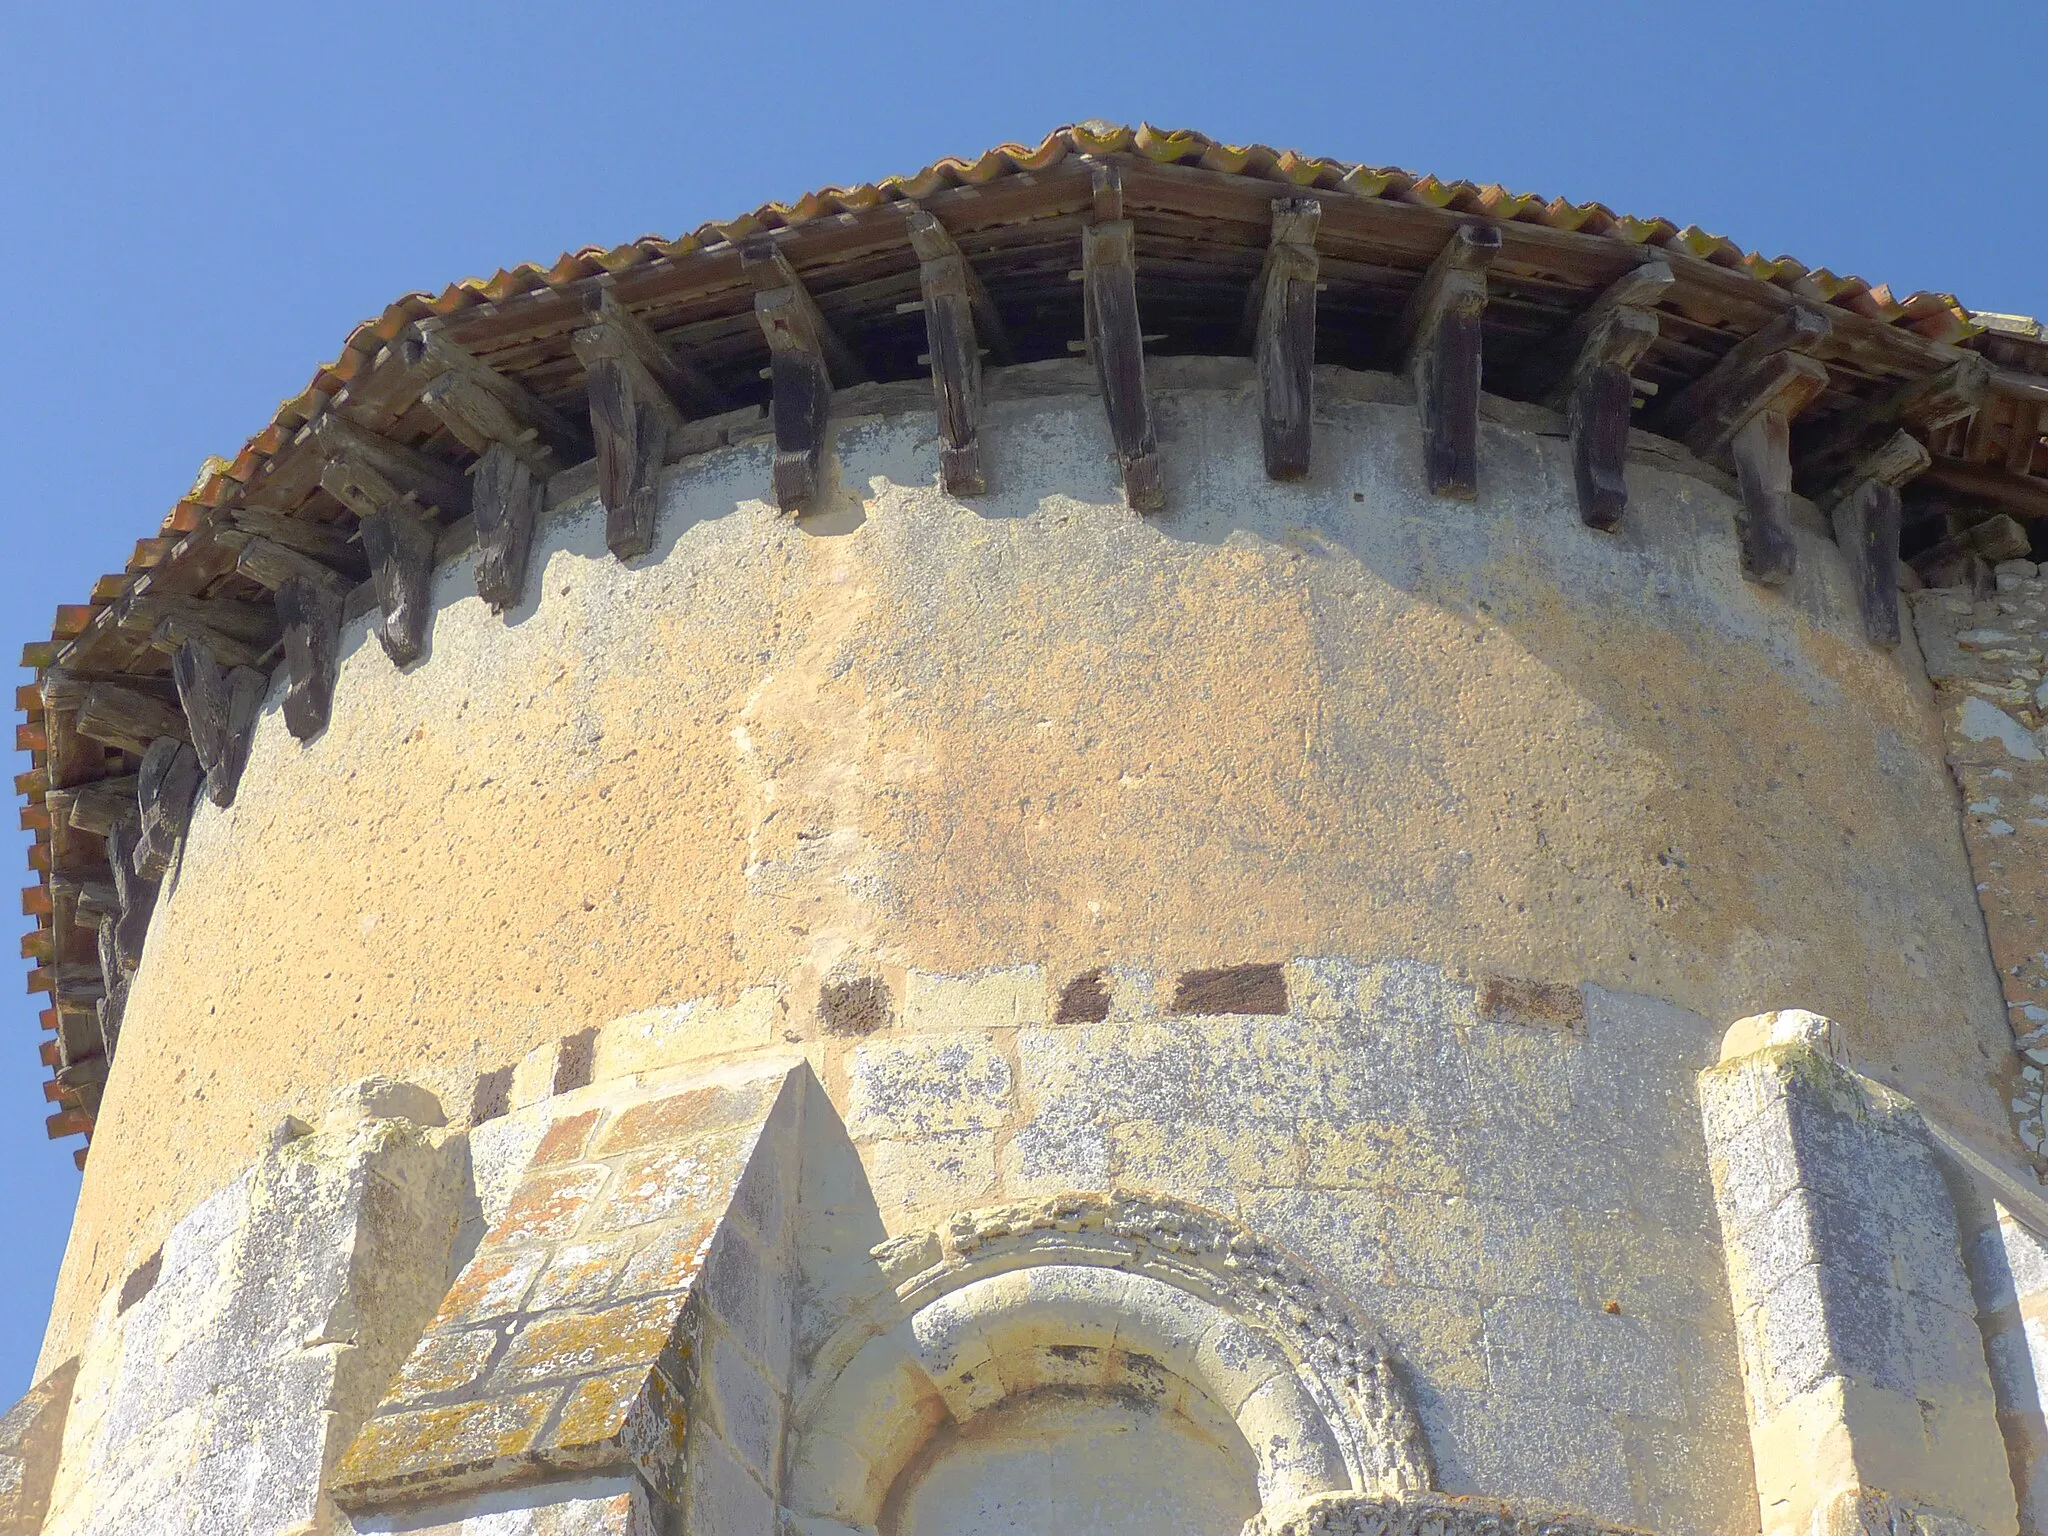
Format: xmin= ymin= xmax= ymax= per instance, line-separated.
xmin=784 ymin=1190 xmax=1434 ymax=1536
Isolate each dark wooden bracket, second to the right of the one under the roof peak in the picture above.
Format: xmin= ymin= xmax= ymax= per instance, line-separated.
xmin=1395 ymin=223 xmax=1501 ymax=500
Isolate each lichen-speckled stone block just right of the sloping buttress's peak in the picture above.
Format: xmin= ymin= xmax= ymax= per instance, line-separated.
xmin=846 ymin=1030 xmax=1011 ymax=1141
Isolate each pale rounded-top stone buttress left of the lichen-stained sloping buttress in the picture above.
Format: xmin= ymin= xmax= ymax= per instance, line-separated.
xmin=43 ymin=1079 xmax=467 ymax=1536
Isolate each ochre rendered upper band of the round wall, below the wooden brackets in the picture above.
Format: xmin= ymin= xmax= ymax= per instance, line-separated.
xmin=47 ymin=360 xmax=2011 ymax=1417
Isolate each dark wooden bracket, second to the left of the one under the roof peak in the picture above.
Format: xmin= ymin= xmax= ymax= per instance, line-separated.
xmin=739 ymin=236 xmax=866 ymax=512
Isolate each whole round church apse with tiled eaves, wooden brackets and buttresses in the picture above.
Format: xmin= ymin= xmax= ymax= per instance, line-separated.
xmin=0 ymin=127 xmax=2048 ymax=1536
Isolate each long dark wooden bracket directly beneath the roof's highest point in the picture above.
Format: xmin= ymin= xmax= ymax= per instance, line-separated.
xmin=1081 ymin=164 xmax=1165 ymax=512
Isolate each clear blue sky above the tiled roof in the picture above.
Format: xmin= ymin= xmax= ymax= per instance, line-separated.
xmin=0 ymin=0 xmax=2048 ymax=1405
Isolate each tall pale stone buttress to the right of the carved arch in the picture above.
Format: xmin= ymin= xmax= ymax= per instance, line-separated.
xmin=1700 ymin=1010 xmax=2017 ymax=1536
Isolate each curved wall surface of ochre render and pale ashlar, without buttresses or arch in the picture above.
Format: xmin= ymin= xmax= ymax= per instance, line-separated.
xmin=28 ymin=365 xmax=2011 ymax=1530
